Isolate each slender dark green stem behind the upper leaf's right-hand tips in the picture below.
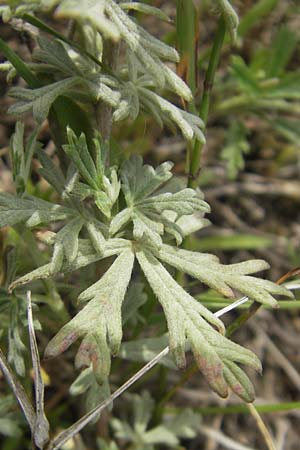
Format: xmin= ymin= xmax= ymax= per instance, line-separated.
xmin=188 ymin=17 xmax=226 ymax=188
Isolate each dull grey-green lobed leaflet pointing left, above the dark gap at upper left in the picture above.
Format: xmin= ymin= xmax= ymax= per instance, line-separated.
xmin=9 ymin=77 xmax=82 ymax=123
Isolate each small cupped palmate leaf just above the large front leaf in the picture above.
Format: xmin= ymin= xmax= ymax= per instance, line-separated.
xmin=110 ymin=156 xmax=209 ymax=248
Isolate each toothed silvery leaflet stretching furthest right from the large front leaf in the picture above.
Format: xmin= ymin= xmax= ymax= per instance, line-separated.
xmin=155 ymin=245 xmax=293 ymax=306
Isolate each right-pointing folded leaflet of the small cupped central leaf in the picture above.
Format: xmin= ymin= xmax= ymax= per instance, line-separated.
xmin=137 ymin=188 xmax=210 ymax=216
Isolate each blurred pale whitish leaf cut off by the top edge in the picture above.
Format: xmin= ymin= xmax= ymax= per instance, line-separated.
xmin=55 ymin=0 xmax=120 ymax=41
